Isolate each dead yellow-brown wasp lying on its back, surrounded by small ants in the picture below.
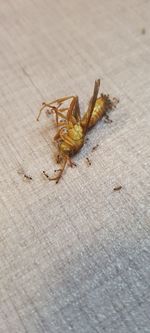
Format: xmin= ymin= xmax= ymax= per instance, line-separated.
xmin=37 ymin=79 xmax=116 ymax=183
